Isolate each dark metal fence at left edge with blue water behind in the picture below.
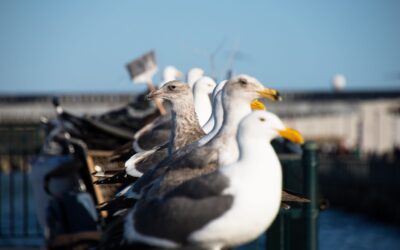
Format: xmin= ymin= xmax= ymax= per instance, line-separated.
xmin=0 ymin=124 xmax=43 ymax=247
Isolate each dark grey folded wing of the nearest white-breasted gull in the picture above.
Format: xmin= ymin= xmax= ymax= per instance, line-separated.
xmin=133 ymin=173 xmax=233 ymax=244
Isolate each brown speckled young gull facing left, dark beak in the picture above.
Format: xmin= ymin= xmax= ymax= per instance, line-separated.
xmin=95 ymin=80 xmax=206 ymax=184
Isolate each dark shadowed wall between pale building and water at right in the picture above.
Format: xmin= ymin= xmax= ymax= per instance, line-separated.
xmin=320 ymin=153 xmax=400 ymax=225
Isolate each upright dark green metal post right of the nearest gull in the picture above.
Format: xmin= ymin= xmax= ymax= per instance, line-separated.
xmin=303 ymin=142 xmax=319 ymax=250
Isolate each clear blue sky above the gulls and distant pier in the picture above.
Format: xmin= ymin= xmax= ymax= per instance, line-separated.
xmin=0 ymin=0 xmax=400 ymax=93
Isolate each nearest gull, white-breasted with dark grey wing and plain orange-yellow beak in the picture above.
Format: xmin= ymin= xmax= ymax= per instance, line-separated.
xmin=100 ymin=111 xmax=303 ymax=250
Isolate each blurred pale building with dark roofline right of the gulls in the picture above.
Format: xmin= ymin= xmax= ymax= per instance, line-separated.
xmin=267 ymin=91 xmax=400 ymax=153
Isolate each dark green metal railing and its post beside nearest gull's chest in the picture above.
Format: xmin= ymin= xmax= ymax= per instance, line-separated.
xmin=266 ymin=142 xmax=319 ymax=250
